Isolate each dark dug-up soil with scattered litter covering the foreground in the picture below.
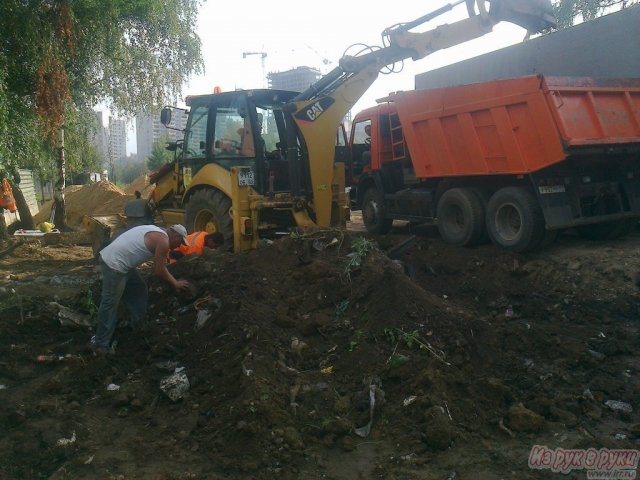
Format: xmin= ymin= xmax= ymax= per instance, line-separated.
xmin=0 ymin=223 xmax=640 ymax=480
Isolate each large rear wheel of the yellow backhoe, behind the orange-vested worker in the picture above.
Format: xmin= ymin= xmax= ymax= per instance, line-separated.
xmin=185 ymin=188 xmax=233 ymax=248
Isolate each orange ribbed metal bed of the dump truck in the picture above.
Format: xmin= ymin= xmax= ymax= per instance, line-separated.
xmin=387 ymin=75 xmax=640 ymax=178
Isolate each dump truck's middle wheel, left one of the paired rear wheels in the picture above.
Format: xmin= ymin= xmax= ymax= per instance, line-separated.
xmin=436 ymin=188 xmax=485 ymax=247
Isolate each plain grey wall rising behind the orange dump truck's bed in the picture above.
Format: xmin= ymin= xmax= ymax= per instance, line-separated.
xmin=415 ymin=5 xmax=640 ymax=90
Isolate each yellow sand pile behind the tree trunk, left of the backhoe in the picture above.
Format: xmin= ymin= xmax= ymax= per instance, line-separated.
xmin=34 ymin=180 xmax=132 ymax=227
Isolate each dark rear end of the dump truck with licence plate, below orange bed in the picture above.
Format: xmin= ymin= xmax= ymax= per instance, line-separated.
xmin=531 ymin=162 xmax=640 ymax=230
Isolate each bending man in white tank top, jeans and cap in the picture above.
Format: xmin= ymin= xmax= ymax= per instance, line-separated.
xmin=89 ymin=225 xmax=189 ymax=354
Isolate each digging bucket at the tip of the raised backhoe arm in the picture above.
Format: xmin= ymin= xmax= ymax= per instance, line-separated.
xmin=490 ymin=0 xmax=556 ymax=33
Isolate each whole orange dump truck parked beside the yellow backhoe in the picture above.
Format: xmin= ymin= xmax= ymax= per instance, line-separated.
xmin=346 ymin=75 xmax=640 ymax=252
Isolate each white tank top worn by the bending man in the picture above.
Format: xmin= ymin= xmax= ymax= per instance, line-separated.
xmin=100 ymin=225 xmax=167 ymax=273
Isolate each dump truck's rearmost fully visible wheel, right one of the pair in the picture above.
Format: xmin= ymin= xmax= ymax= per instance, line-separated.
xmin=487 ymin=187 xmax=545 ymax=252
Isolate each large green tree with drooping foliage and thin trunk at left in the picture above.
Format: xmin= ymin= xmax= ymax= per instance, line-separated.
xmin=0 ymin=0 xmax=202 ymax=226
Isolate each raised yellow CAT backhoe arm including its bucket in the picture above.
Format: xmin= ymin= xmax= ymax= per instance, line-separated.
xmin=288 ymin=0 xmax=555 ymax=227
